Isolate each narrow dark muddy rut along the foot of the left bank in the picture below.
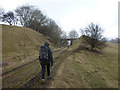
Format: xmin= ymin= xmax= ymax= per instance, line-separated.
xmin=0 ymin=50 xmax=60 ymax=77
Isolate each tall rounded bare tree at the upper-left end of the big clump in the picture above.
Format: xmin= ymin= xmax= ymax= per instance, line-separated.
xmin=15 ymin=5 xmax=46 ymax=27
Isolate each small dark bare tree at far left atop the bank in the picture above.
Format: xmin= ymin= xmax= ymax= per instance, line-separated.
xmin=2 ymin=11 xmax=15 ymax=25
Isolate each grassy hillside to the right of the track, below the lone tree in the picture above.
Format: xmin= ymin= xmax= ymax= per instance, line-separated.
xmin=49 ymin=37 xmax=118 ymax=88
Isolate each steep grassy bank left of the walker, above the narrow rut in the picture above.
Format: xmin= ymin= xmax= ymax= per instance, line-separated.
xmin=2 ymin=25 xmax=52 ymax=72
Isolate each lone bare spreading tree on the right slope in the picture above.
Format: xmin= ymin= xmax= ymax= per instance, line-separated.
xmin=81 ymin=23 xmax=105 ymax=50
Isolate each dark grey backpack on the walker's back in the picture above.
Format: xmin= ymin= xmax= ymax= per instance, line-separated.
xmin=39 ymin=46 xmax=49 ymax=64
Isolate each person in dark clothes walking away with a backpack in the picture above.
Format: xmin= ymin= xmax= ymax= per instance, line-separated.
xmin=39 ymin=42 xmax=53 ymax=84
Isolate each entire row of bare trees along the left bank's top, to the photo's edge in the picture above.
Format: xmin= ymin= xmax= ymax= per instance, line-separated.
xmin=0 ymin=5 xmax=61 ymax=45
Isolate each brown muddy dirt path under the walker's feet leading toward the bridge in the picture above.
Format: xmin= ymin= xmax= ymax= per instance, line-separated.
xmin=20 ymin=49 xmax=67 ymax=88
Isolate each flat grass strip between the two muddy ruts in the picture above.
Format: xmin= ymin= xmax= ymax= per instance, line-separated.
xmin=2 ymin=43 xmax=63 ymax=88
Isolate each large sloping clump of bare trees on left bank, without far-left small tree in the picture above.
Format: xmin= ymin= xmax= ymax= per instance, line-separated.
xmin=15 ymin=5 xmax=61 ymax=45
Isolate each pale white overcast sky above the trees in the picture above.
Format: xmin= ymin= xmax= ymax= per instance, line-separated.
xmin=0 ymin=0 xmax=119 ymax=38
